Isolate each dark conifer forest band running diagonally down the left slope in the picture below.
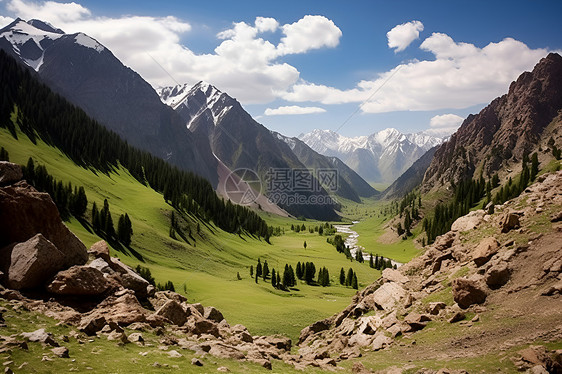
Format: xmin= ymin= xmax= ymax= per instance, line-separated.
xmin=0 ymin=51 xmax=270 ymax=241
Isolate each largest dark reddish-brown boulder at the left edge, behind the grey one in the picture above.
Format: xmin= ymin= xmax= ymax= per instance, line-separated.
xmin=0 ymin=182 xmax=88 ymax=267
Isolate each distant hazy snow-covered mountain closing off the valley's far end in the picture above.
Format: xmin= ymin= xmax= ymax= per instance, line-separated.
xmin=299 ymin=128 xmax=443 ymax=183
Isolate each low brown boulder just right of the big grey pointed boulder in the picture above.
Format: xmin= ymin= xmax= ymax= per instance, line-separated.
xmin=47 ymin=266 xmax=109 ymax=296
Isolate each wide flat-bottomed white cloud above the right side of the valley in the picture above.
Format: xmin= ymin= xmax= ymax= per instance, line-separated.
xmin=281 ymin=33 xmax=548 ymax=113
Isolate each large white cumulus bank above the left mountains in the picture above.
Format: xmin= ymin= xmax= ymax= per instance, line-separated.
xmin=7 ymin=0 xmax=341 ymax=104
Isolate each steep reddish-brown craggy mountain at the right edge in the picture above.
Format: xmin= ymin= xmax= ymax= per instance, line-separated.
xmin=422 ymin=53 xmax=562 ymax=191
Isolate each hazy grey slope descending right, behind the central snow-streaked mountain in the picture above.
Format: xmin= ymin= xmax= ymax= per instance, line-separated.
xmin=272 ymin=131 xmax=378 ymax=202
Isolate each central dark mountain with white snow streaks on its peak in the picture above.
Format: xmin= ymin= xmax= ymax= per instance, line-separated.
xmin=159 ymin=82 xmax=339 ymax=220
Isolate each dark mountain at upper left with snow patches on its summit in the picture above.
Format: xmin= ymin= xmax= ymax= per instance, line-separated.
xmin=0 ymin=18 xmax=218 ymax=186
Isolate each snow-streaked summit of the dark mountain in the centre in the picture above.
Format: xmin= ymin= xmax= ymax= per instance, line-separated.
xmin=157 ymin=81 xmax=234 ymax=129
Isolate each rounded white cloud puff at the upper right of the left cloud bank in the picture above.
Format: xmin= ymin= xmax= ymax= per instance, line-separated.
xmin=278 ymin=16 xmax=342 ymax=55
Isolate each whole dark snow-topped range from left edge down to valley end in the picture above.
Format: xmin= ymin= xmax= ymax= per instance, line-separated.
xmin=0 ymin=18 xmax=377 ymax=219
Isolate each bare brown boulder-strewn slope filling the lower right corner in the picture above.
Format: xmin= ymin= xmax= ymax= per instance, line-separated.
xmin=298 ymin=171 xmax=562 ymax=373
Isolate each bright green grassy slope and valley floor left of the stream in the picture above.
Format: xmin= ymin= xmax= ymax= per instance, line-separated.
xmin=0 ymin=129 xmax=390 ymax=339
